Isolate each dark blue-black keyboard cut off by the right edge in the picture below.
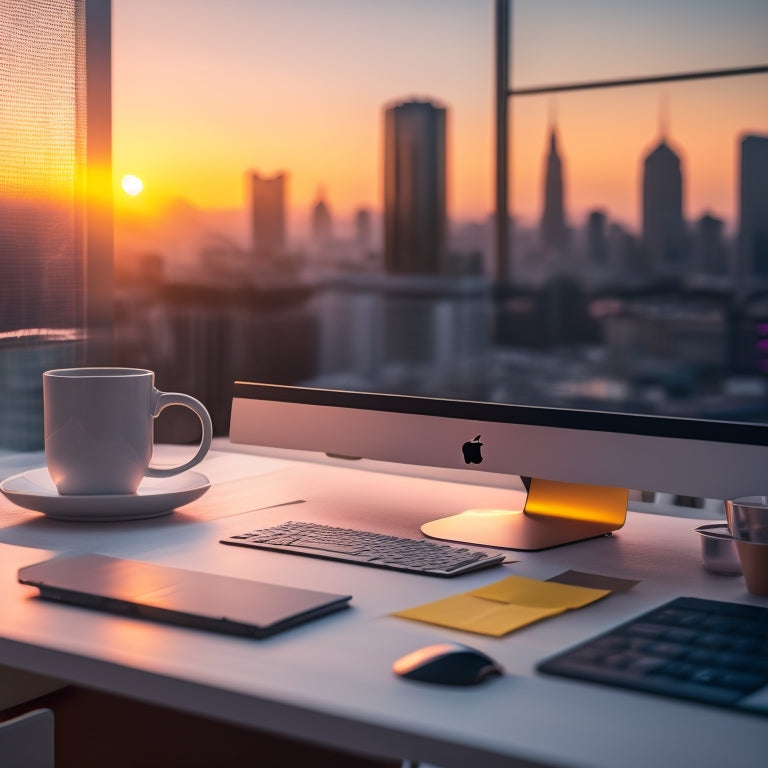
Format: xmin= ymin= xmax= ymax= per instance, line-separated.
xmin=538 ymin=597 xmax=768 ymax=716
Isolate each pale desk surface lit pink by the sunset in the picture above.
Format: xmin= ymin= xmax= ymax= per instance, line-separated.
xmin=0 ymin=443 xmax=768 ymax=768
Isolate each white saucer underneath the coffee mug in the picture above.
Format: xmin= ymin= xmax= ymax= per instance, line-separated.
xmin=0 ymin=467 xmax=211 ymax=522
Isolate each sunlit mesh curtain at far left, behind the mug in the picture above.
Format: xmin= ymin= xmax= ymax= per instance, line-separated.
xmin=0 ymin=0 xmax=86 ymax=451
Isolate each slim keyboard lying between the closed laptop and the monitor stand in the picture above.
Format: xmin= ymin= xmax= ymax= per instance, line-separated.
xmin=221 ymin=521 xmax=505 ymax=576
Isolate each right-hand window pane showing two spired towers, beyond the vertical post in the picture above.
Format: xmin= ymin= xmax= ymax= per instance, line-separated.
xmin=500 ymin=2 xmax=768 ymax=421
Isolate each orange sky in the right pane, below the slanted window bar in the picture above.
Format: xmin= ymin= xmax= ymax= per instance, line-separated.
xmin=510 ymin=77 xmax=768 ymax=228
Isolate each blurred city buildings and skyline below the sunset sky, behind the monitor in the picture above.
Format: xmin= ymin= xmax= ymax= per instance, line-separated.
xmin=115 ymin=99 xmax=768 ymax=441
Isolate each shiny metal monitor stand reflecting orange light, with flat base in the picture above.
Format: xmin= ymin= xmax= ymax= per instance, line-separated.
xmin=421 ymin=478 xmax=629 ymax=551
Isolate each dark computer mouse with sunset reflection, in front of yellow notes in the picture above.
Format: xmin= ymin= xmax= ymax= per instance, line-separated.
xmin=392 ymin=643 xmax=504 ymax=685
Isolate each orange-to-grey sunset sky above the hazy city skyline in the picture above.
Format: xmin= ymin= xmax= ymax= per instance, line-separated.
xmin=113 ymin=0 xmax=768 ymax=237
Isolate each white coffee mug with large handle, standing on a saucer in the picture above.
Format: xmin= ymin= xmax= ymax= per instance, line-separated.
xmin=43 ymin=368 xmax=213 ymax=495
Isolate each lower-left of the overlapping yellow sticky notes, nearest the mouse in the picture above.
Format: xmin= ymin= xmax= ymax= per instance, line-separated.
xmin=394 ymin=593 xmax=560 ymax=637
